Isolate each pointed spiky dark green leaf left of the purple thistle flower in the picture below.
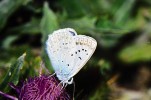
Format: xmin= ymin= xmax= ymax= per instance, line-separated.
xmin=0 ymin=53 xmax=26 ymax=91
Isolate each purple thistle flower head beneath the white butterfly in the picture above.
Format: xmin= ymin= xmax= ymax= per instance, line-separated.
xmin=0 ymin=75 xmax=70 ymax=100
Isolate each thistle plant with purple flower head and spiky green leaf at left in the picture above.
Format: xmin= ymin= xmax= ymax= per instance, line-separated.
xmin=0 ymin=54 xmax=70 ymax=100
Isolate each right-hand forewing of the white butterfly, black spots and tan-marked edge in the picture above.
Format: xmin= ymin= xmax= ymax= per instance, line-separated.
xmin=69 ymin=35 xmax=97 ymax=77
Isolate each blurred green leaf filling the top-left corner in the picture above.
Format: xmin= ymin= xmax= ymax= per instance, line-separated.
xmin=0 ymin=0 xmax=29 ymax=30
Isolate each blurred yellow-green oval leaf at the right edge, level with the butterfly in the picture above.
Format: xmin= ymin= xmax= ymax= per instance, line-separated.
xmin=119 ymin=44 xmax=151 ymax=63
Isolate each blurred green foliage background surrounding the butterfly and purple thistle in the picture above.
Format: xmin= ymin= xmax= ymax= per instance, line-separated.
xmin=0 ymin=0 xmax=151 ymax=100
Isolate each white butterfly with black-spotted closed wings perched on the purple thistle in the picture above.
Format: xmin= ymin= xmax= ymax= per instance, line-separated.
xmin=46 ymin=28 xmax=97 ymax=86
